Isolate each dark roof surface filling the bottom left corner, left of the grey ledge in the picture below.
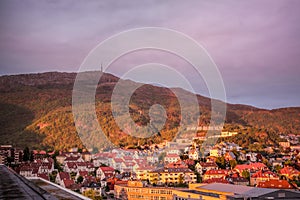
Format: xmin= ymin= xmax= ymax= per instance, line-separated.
xmin=0 ymin=165 xmax=44 ymax=200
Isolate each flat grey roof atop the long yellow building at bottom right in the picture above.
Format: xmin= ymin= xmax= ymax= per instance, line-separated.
xmin=198 ymin=183 xmax=277 ymax=197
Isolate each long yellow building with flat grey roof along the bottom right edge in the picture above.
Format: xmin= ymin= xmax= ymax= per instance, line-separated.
xmin=115 ymin=181 xmax=300 ymax=200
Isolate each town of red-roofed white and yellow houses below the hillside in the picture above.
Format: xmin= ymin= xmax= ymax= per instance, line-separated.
xmin=0 ymin=133 xmax=300 ymax=199
